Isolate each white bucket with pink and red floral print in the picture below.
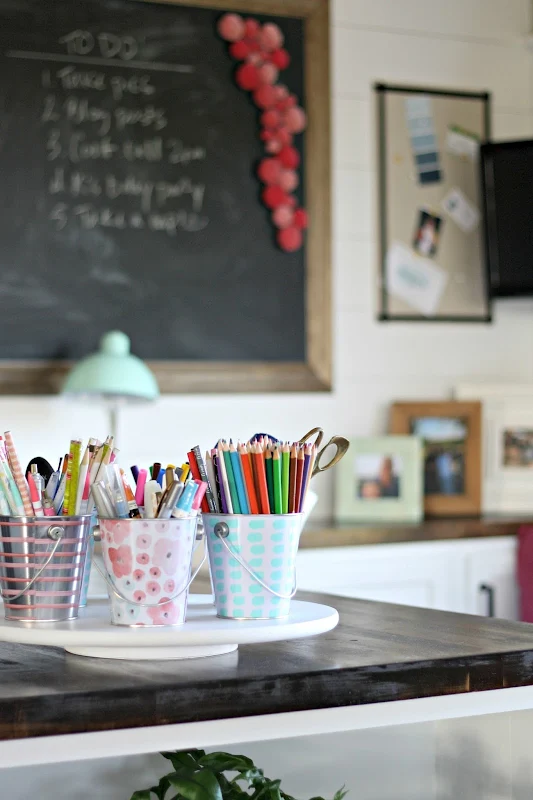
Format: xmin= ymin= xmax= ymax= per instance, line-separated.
xmin=100 ymin=516 xmax=203 ymax=626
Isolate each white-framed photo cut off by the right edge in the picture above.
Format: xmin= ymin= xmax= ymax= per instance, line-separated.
xmin=454 ymin=384 xmax=533 ymax=514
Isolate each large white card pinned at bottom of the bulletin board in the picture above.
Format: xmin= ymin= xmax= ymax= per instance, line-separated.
xmin=387 ymin=242 xmax=448 ymax=317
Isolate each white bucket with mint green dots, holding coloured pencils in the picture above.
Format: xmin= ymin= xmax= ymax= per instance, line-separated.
xmin=203 ymin=514 xmax=304 ymax=620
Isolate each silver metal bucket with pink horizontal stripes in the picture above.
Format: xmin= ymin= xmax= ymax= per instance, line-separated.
xmin=0 ymin=515 xmax=92 ymax=622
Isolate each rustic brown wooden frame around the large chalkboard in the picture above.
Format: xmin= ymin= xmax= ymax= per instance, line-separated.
xmin=0 ymin=0 xmax=332 ymax=395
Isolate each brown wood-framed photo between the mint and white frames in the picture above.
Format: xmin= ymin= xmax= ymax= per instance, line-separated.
xmin=390 ymin=402 xmax=481 ymax=517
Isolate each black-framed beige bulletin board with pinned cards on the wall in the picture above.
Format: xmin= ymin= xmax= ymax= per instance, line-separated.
xmin=375 ymin=84 xmax=491 ymax=322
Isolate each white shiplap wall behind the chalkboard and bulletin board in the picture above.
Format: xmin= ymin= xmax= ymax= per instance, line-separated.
xmin=0 ymin=0 xmax=533 ymax=518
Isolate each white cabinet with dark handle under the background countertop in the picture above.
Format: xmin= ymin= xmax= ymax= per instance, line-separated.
xmin=298 ymin=537 xmax=517 ymax=619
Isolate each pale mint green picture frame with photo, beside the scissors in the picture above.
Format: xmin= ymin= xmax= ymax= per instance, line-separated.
xmin=335 ymin=436 xmax=423 ymax=522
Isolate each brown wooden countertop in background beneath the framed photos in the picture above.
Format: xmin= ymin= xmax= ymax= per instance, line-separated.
xmin=300 ymin=514 xmax=533 ymax=549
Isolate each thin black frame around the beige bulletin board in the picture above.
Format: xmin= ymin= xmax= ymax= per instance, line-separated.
xmin=374 ymin=83 xmax=492 ymax=323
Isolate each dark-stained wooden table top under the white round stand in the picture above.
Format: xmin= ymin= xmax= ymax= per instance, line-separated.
xmin=0 ymin=593 xmax=533 ymax=739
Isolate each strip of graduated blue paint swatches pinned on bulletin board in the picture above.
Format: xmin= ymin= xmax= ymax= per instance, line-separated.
xmin=405 ymin=96 xmax=442 ymax=185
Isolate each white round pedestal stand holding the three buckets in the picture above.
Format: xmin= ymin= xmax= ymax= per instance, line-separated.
xmin=0 ymin=595 xmax=339 ymax=661
